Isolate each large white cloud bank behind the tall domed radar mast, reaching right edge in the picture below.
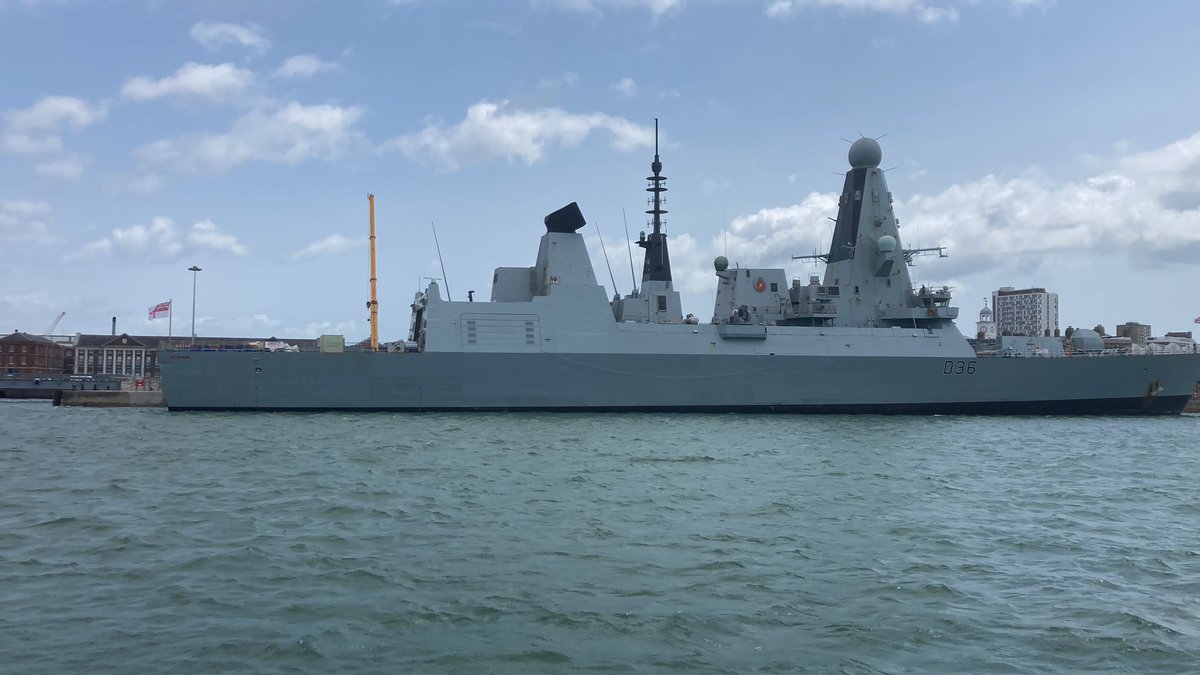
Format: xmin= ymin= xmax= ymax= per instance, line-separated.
xmin=705 ymin=132 xmax=1200 ymax=282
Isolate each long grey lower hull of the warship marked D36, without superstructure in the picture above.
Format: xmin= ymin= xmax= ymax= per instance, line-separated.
xmin=161 ymin=352 xmax=1200 ymax=416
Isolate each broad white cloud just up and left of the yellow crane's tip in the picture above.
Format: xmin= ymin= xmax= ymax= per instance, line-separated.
xmin=137 ymin=102 xmax=362 ymax=173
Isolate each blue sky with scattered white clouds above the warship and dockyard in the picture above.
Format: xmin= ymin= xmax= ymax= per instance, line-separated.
xmin=0 ymin=0 xmax=1200 ymax=341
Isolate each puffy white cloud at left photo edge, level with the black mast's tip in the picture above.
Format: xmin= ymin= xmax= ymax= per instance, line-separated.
xmin=0 ymin=96 xmax=108 ymax=155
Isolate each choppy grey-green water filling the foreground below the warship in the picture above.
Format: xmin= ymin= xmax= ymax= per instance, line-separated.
xmin=0 ymin=402 xmax=1200 ymax=674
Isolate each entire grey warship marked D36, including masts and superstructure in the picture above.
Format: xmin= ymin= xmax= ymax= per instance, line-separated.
xmin=161 ymin=133 xmax=1200 ymax=416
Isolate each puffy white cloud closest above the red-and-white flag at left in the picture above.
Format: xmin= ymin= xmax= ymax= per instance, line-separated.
xmin=64 ymin=216 xmax=250 ymax=262
